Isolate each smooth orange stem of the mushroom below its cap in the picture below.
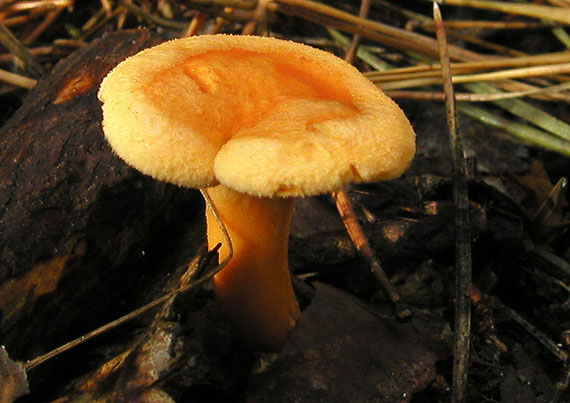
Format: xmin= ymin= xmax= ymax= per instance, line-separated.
xmin=206 ymin=185 xmax=300 ymax=350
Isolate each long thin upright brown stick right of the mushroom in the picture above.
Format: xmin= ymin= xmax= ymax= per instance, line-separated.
xmin=433 ymin=1 xmax=471 ymax=403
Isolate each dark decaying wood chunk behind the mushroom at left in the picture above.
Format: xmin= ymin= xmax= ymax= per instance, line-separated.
xmin=0 ymin=30 xmax=200 ymax=372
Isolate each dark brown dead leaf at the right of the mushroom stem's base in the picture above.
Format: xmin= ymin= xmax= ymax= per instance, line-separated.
xmin=246 ymin=284 xmax=444 ymax=403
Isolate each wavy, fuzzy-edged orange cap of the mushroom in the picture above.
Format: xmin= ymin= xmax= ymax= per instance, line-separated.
xmin=99 ymin=35 xmax=415 ymax=196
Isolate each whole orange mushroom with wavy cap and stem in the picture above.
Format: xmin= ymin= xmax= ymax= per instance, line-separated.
xmin=95 ymin=35 xmax=415 ymax=350
